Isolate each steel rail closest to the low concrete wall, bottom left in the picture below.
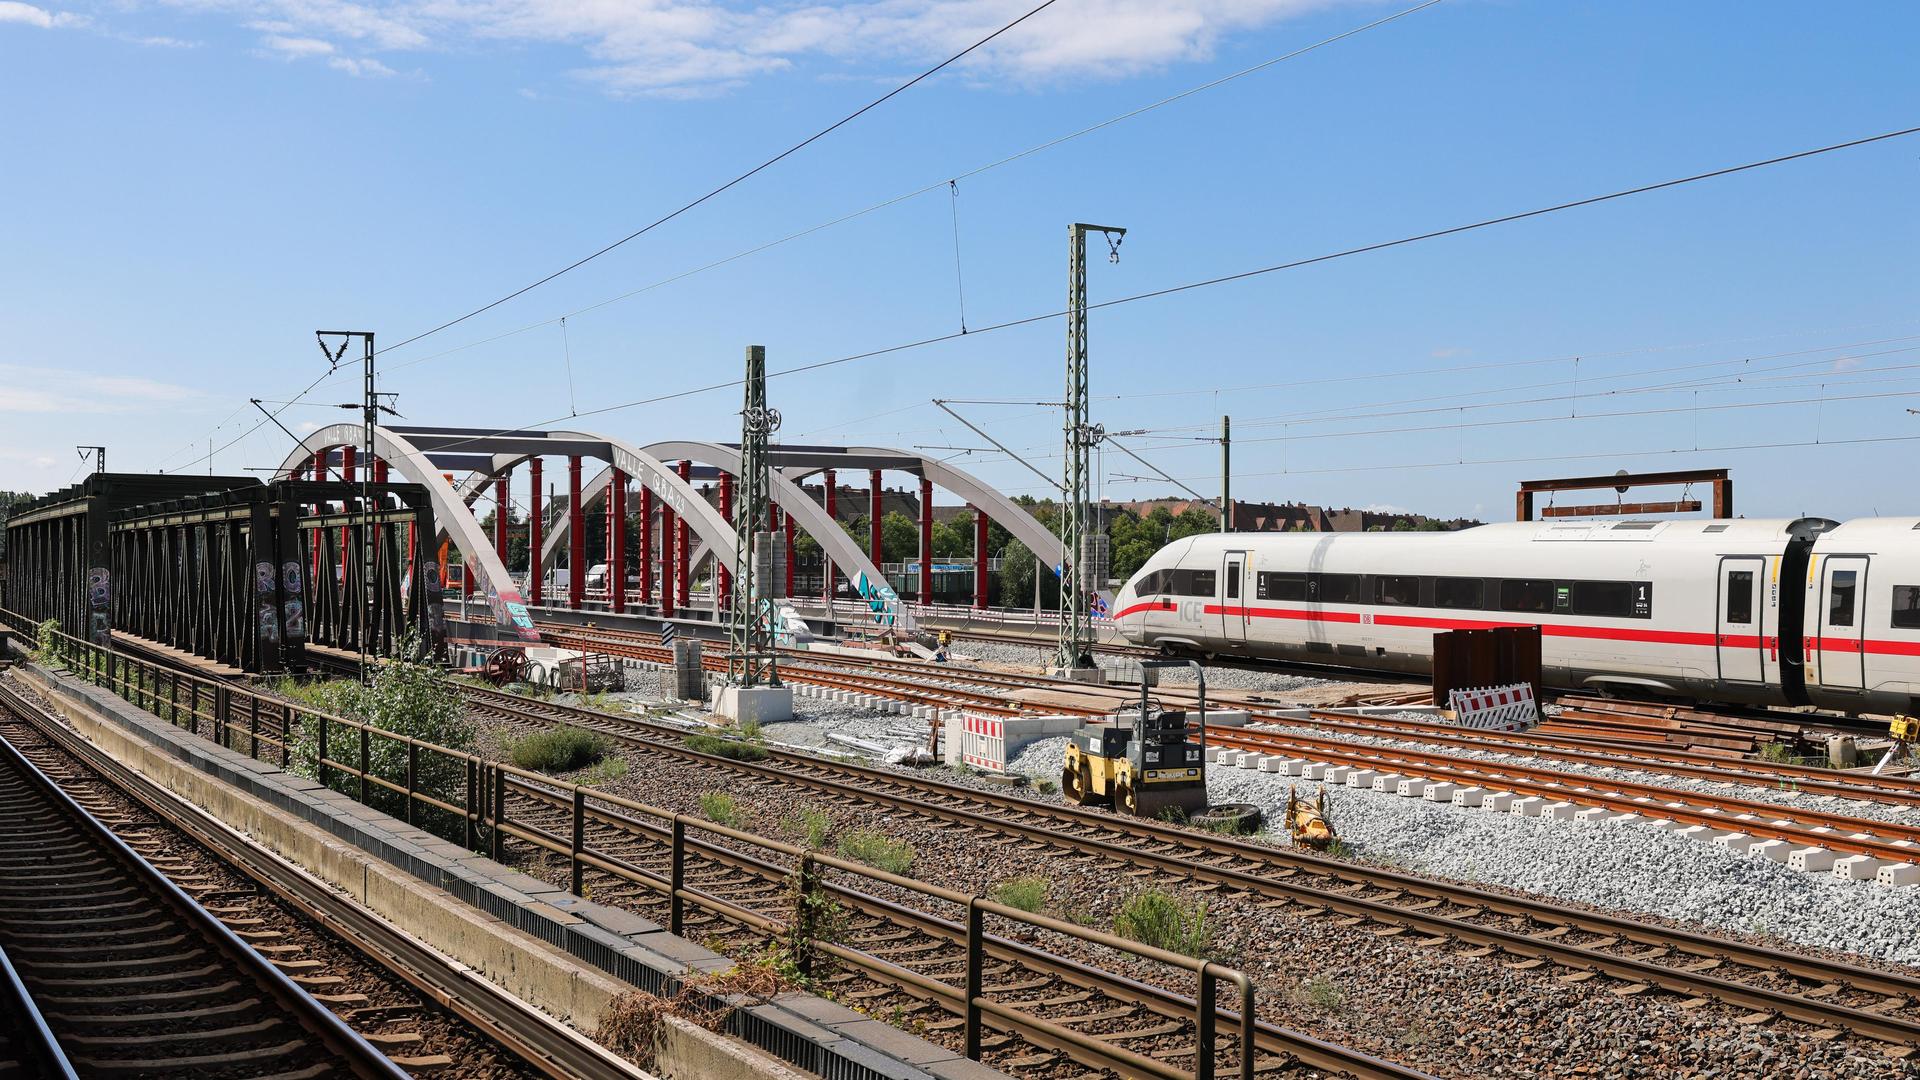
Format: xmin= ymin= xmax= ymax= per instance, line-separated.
xmin=0 ymin=686 xmax=637 ymax=1080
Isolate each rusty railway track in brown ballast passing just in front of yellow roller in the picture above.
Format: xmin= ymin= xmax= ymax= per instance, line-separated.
xmin=456 ymin=690 xmax=1920 ymax=1053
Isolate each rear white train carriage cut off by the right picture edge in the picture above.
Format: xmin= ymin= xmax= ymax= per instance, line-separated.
xmin=1803 ymin=517 xmax=1920 ymax=715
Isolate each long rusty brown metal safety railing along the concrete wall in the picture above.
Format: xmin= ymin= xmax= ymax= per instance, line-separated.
xmin=11 ymin=609 xmax=1256 ymax=1080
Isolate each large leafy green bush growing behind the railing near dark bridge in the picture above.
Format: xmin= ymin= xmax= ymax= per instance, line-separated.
xmin=288 ymin=648 xmax=474 ymax=836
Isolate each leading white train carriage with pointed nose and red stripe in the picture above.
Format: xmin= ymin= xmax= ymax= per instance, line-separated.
xmin=1114 ymin=519 xmax=1835 ymax=707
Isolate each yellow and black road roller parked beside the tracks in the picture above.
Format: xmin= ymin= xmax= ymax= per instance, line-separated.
xmin=1060 ymin=661 xmax=1208 ymax=819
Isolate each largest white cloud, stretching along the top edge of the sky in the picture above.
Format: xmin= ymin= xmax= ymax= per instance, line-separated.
xmin=149 ymin=0 xmax=1361 ymax=96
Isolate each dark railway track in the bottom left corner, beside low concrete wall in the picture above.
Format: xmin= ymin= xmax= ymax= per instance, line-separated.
xmin=0 ymin=684 xmax=637 ymax=1080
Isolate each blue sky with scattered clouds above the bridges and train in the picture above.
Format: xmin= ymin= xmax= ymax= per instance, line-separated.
xmin=0 ymin=0 xmax=1920 ymax=519
